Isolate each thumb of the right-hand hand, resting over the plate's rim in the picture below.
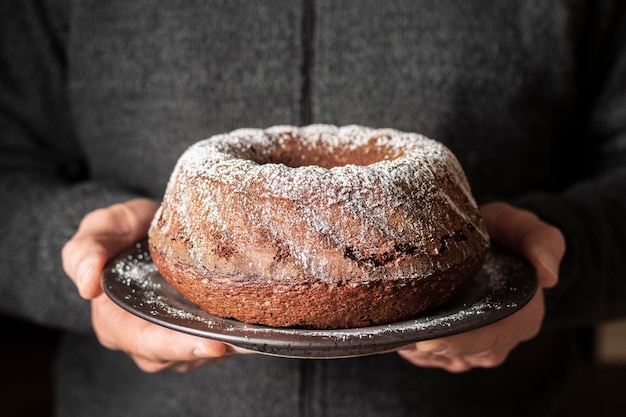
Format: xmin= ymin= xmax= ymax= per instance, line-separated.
xmin=481 ymin=202 xmax=565 ymax=288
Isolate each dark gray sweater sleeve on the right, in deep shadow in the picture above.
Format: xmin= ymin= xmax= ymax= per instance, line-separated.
xmin=515 ymin=2 xmax=626 ymax=327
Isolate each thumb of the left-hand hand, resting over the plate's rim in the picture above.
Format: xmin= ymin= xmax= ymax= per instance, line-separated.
xmin=62 ymin=199 xmax=158 ymax=299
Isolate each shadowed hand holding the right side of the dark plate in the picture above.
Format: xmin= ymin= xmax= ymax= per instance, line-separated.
xmin=398 ymin=202 xmax=565 ymax=372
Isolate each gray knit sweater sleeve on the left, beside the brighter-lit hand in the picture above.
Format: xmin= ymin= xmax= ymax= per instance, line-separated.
xmin=0 ymin=0 xmax=139 ymax=332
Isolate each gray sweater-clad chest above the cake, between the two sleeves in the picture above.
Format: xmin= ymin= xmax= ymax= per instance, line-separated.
xmin=68 ymin=0 xmax=576 ymax=200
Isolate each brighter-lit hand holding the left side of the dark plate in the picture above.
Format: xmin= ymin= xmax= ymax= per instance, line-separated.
xmin=62 ymin=199 xmax=245 ymax=372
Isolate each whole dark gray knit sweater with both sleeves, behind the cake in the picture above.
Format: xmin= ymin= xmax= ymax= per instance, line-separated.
xmin=0 ymin=0 xmax=626 ymax=417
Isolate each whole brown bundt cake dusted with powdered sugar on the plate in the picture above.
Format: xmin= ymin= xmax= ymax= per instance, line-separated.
xmin=149 ymin=125 xmax=489 ymax=328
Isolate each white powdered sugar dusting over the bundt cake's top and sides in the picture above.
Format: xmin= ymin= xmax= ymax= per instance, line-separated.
xmin=150 ymin=124 xmax=488 ymax=280
